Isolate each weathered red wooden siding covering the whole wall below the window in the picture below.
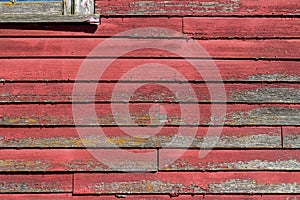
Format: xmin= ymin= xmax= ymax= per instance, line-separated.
xmin=0 ymin=0 xmax=300 ymax=200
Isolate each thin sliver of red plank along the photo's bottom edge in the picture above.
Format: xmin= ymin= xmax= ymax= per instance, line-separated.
xmin=0 ymin=194 xmax=300 ymax=200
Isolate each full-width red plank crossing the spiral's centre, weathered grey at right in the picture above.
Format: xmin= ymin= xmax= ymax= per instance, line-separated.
xmin=0 ymin=103 xmax=300 ymax=126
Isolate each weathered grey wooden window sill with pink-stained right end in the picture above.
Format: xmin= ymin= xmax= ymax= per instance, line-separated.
xmin=0 ymin=14 xmax=100 ymax=25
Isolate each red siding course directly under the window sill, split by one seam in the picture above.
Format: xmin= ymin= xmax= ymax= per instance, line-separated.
xmin=0 ymin=17 xmax=300 ymax=39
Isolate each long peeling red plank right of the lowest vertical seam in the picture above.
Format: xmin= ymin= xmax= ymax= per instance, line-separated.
xmin=74 ymin=172 xmax=300 ymax=195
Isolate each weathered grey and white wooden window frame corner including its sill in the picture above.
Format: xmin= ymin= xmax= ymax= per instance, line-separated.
xmin=0 ymin=0 xmax=100 ymax=24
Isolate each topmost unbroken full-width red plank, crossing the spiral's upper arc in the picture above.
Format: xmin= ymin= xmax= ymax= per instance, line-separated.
xmin=0 ymin=38 xmax=300 ymax=59
